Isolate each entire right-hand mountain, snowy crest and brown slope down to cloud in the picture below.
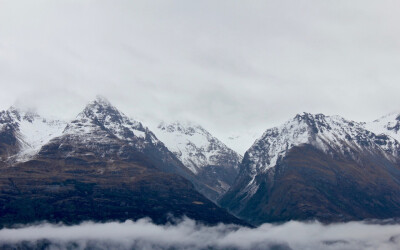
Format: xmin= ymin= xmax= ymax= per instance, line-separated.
xmin=221 ymin=113 xmax=400 ymax=224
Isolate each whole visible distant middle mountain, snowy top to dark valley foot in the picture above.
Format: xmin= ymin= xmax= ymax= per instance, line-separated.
xmin=155 ymin=122 xmax=242 ymax=200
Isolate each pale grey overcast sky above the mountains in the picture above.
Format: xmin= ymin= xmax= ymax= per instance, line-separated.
xmin=0 ymin=0 xmax=400 ymax=148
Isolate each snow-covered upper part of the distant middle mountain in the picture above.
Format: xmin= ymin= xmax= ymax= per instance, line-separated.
xmin=155 ymin=121 xmax=241 ymax=174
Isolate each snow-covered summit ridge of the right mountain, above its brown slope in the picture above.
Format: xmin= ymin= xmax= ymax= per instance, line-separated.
xmin=245 ymin=113 xmax=400 ymax=174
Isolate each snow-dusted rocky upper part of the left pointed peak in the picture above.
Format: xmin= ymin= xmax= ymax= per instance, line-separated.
xmin=39 ymin=97 xmax=218 ymax=197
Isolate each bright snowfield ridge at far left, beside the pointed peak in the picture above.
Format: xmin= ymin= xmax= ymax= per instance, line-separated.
xmin=0 ymin=106 xmax=67 ymax=161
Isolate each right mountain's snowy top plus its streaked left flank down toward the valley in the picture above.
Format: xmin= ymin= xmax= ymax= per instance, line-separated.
xmin=222 ymin=113 xmax=400 ymax=214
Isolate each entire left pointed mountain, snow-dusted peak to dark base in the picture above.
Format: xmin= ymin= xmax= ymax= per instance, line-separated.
xmin=0 ymin=98 xmax=242 ymax=226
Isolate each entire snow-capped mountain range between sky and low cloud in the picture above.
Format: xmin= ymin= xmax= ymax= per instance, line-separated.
xmin=0 ymin=97 xmax=400 ymax=226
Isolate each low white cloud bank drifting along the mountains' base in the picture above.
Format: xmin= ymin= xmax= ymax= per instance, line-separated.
xmin=0 ymin=219 xmax=400 ymax=250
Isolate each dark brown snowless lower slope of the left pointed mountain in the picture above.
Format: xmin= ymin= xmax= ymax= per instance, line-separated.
xmin=0 ymin=154 xmax=242 ymax=226
